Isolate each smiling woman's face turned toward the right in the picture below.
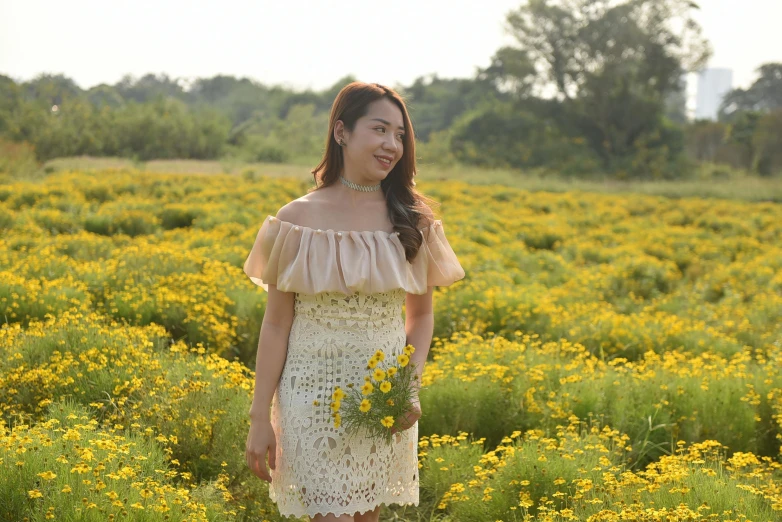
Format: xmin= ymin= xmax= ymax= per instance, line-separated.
xmin=335 ymin=98 xmax=405 ymax=184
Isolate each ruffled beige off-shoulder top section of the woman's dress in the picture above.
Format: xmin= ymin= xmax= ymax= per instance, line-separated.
xmin=244 ymin=211 xmax=464 ymax=295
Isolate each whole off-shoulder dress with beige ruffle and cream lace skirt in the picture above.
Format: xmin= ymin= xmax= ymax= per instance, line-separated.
xmin=244 ymin=216 xmax=465 ymax=517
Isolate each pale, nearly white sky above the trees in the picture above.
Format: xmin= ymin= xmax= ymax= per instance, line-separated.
xmin=0 ymin=0 xmax=782 ymax=90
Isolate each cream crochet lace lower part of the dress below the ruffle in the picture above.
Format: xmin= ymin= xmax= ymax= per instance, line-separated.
xmin=269 ymin=289 xmax=419 ymax=517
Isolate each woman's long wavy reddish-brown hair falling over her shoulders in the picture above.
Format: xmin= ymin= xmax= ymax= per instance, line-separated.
xmin=311 ymin=82 xmax=437 ymax=262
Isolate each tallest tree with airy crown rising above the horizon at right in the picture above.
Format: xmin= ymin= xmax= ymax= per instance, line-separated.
xmin=468 ymin=0 xmax=710 ymax=176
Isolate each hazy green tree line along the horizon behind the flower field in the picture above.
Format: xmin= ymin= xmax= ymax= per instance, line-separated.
xmin=0 ymin=0 xmax=782 ymax=179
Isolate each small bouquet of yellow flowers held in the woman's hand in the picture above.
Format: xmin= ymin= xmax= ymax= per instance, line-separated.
xmin=318 ymin=344 xmax=418 ymax=444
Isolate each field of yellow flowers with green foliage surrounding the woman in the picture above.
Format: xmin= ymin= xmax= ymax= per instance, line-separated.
xmin=0 ymin=169 xmax=782 ymax=522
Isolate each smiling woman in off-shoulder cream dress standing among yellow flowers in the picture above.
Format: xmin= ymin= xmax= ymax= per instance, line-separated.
xmin=244 ymin=82 xmax=464 ymax=522
